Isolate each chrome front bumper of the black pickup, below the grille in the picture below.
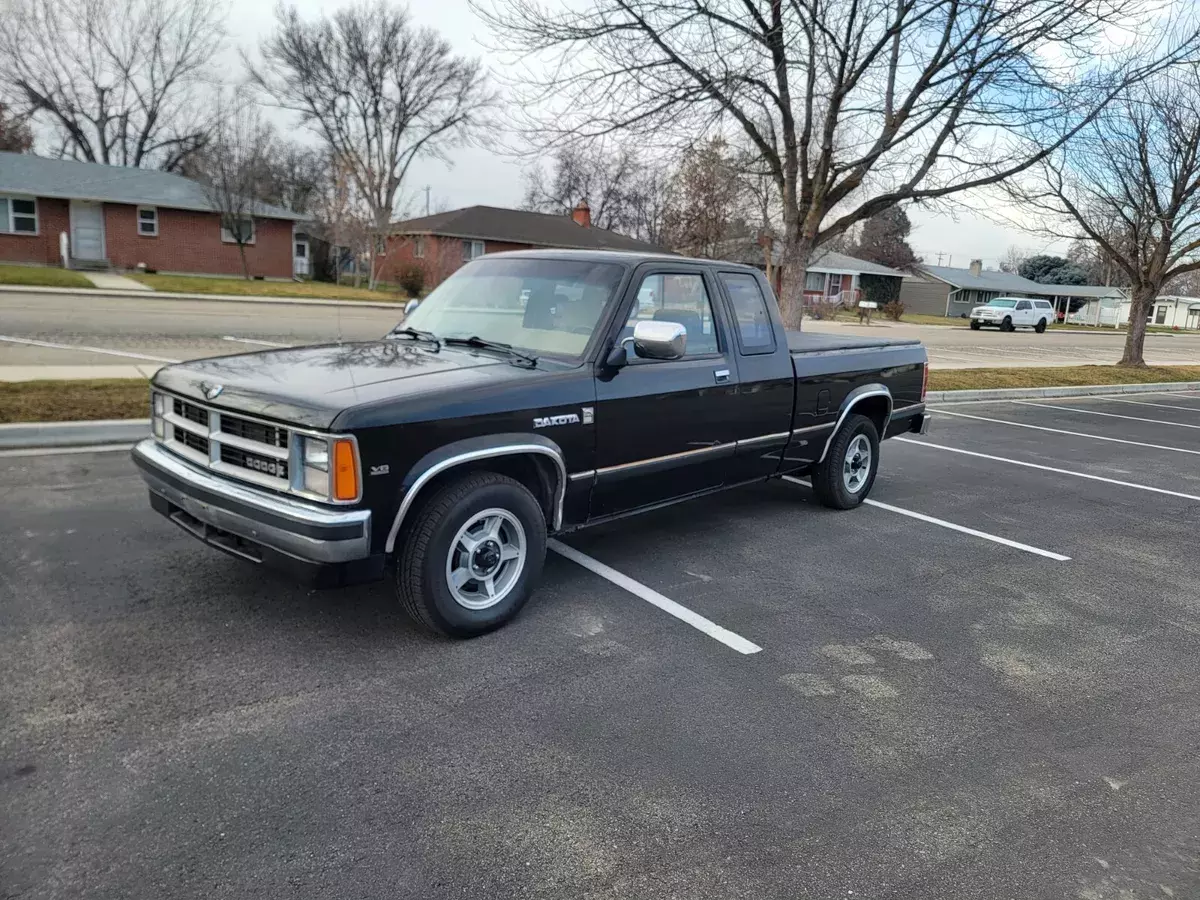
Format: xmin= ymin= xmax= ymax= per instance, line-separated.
xmin=133 ymin=438 xmax=371 ymax=564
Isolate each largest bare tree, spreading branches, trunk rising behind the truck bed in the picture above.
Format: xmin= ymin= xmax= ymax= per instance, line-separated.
xmin=475 ymin=0 xmax=1195 ymax=326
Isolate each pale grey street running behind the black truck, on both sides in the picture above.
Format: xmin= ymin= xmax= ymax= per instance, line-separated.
xmin=0 ymin=292 xmax=1200 ymax=380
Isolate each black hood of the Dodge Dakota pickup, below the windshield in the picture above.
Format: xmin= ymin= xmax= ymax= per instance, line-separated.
xmin=154 ymin=340 xmax=538 ymax=428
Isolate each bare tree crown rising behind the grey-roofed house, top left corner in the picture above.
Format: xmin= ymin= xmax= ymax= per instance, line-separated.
xmin=0 ymin=0 xmax=226 ymax=170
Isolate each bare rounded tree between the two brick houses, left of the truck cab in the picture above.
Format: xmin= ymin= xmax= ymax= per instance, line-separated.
xmin=247 ymin=0 xmax=493 ymax=287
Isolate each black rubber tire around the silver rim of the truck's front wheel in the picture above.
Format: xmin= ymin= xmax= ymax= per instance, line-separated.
xmin=396 ymin=472 xmax=546 ymax=637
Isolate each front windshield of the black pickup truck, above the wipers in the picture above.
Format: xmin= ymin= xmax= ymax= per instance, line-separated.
xmin=404 ymin=259 xmax=623 ymax=359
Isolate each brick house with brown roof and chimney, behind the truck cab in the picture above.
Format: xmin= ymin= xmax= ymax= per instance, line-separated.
xmin=380 ymin=202 xmax=666 ymax=288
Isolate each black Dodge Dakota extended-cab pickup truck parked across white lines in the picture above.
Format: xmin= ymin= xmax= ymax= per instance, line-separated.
xmin=133 ymin=251 xmax=929 ymax=636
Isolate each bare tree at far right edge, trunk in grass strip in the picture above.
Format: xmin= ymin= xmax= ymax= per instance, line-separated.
xmin=1014 ymin=66 xmax=1200 ymax=366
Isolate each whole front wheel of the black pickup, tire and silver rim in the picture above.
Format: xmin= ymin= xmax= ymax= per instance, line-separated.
xmin=396 ymin=472 xmax=546 ymax=637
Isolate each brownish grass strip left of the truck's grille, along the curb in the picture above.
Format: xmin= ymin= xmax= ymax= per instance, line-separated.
xmin=0 ymin=378 xmax=150 ymax=424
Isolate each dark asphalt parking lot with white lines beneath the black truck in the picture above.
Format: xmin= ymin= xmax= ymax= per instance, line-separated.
xmin=0 ymin=392 xmax=1200 ymax=900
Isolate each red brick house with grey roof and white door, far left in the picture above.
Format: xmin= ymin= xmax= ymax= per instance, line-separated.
xmin=0 ymin=152 xmax=307 ymax=278
